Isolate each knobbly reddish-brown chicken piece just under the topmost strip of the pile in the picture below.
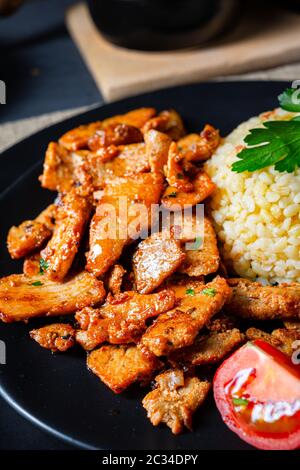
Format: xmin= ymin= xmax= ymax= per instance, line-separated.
xmin=88 ymin=124 xmax=144 ymax=151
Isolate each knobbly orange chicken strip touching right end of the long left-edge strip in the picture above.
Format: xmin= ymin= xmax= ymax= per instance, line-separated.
xmin=75 ymin=290 xmax=175 ymax=351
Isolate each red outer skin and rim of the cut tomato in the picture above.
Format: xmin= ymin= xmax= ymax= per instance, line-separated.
xmin=213 ymin=341 xmax=300 ymax=450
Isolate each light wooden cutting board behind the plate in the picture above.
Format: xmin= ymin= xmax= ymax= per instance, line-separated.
xmin=66 ymin=3 xmax=300 ymax=101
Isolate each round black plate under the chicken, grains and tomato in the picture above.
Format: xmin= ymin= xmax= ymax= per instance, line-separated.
xmin=0 ymin=82 xmax=287 ymax=450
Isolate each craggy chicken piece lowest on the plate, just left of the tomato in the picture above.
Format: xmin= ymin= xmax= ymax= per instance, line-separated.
xmin=143 ymin=369 xmax=210 ymax=434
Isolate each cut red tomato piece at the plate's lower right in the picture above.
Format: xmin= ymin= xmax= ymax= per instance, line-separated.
xmin=214 ymin=340 xmax=300 ymax=450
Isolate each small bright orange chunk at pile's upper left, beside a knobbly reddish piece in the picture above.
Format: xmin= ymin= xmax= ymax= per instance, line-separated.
xmin=59 ymin=121 xmax=102 ymax=151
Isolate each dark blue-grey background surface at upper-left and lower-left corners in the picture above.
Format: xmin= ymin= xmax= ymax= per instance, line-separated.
xmin=0 ymin=0 xmax=103 ymax=450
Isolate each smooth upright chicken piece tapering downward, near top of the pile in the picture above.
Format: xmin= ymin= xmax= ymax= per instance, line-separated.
xmin=144 ymin=130 xmax=172 ymax=174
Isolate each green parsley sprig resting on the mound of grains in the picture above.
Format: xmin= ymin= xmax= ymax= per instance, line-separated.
xmin=232 ymin=88 xmax=300 ymax=173
